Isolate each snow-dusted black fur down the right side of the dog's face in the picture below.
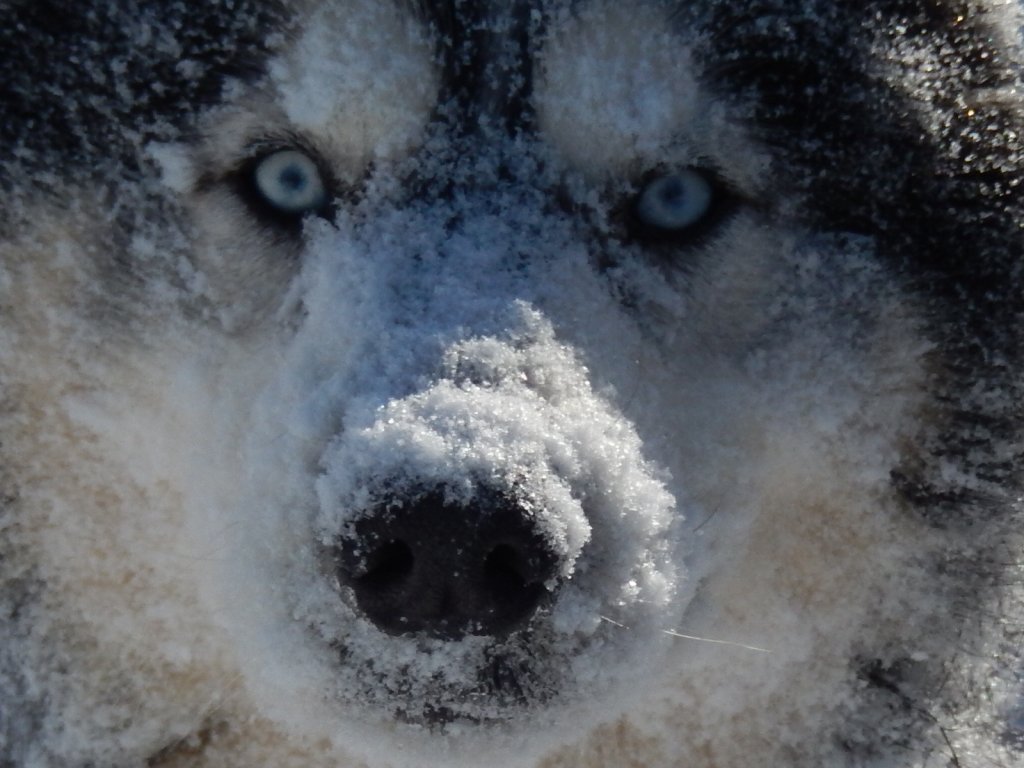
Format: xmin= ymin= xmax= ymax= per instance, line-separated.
xmin=696 ymin=0 xmax=1024 ymax=766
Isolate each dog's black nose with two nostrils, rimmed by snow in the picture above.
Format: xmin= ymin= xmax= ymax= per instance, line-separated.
xmin=337 ymin=490 xmax=558 ymax=639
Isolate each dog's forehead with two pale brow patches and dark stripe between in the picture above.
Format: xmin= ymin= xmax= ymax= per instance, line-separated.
xmin=269 ymin=0 xmax=716 ymax=171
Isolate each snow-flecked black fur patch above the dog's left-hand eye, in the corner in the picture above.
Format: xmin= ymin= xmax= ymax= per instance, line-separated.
xmin=0 ymin=0 xmax=286 ymax=189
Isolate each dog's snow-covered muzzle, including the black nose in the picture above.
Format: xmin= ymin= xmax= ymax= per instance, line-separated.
xmin=188 ymin=174 xmax=684 ymax=730
